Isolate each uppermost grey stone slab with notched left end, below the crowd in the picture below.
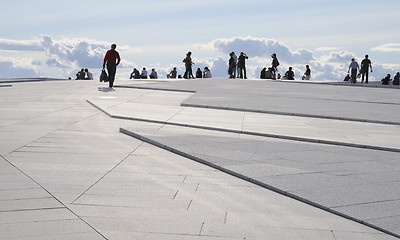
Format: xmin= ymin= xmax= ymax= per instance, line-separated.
xmin=121 ymin=79 xmax=400 ymax=123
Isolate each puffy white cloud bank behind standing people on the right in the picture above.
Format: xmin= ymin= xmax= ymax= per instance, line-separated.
xmin=198 ymin=37 xmax=400 ymax=80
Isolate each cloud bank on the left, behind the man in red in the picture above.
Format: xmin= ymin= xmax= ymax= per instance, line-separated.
xmin=0 ymin=35 xmax=133 ymax=78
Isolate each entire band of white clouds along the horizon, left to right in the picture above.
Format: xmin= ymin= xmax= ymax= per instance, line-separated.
xmin=0 ymin=35 xmax=400 ymax=80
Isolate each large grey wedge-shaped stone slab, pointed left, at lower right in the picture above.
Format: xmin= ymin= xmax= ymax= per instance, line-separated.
xmin=119 ymin=126 xmax=400 ymax=237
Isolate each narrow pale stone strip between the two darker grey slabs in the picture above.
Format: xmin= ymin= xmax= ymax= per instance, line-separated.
xmin=89 ymin=100 xmax=400 ymax=151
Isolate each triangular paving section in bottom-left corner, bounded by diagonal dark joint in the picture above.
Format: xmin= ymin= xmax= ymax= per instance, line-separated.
xmin=0 ymin=157 xmax=103 ymax=239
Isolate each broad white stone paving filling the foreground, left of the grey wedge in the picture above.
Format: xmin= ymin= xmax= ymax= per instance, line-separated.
xmin=0 ymin=81 xmax=394 ymax=240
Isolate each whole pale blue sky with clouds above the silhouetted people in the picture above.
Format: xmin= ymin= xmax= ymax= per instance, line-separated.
xmin=0 ymin=0 xmax=400 ymax=80
